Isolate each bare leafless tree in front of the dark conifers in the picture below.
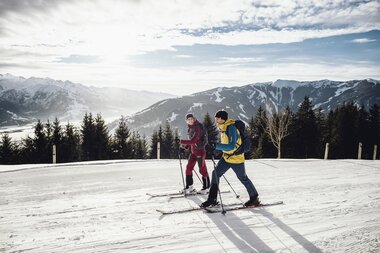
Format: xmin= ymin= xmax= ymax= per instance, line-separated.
xmin=263 ymin=108 xmax=292 ymax=159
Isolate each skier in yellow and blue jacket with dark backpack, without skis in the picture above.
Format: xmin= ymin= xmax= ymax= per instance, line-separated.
xmin=200 ymin=111 xmax=260 ymax=207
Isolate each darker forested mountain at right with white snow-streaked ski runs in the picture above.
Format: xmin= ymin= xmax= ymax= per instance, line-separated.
xmin=124 ymin=79 xmax=380 ymax=138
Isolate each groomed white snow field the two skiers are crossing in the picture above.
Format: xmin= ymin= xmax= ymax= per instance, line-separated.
xmin=0 ymin=160 xmax=380 ymax=253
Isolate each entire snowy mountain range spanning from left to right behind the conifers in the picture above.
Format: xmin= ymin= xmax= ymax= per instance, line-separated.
xmin=0 ymin=74 xmax=380 ymax=137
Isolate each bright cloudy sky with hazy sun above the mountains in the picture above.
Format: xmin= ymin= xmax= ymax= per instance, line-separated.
xmin=0 ymin=0 xmax=380 ymax=95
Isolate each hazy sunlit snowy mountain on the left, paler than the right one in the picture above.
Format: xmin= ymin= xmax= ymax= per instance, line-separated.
xmin=0 ymin=74 xmax=174 ymax=126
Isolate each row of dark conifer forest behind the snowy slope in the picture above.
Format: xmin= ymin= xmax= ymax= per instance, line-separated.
xmin=0 ymin=97 xmax=380 ymax=164
